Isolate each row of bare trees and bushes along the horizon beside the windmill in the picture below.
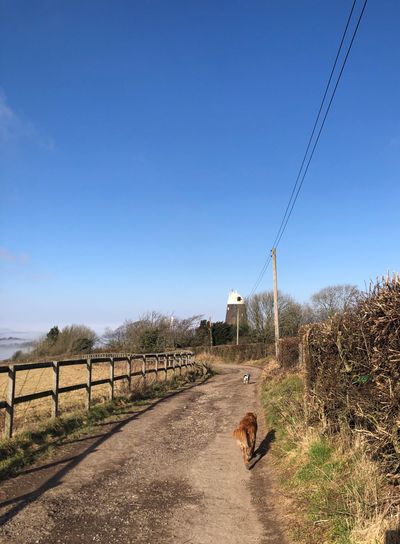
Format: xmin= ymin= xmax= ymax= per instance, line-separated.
xmin=12 ymin=284 xmax=360 ymax=361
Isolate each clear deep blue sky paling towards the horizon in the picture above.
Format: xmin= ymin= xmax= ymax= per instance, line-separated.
xmin=0 ymin=0 xmax=400 ymax=330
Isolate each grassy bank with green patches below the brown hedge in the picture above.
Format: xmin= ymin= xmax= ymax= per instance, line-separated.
xmin=262 ymin=371 xmax=398 ymax=544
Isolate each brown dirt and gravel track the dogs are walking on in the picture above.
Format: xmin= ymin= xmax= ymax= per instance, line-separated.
xmin=0 ymin=367 xmax=287 ymax=544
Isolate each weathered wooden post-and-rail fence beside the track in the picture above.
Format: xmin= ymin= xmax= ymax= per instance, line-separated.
xmin=0 ymin=351 xmax=195 ymax=438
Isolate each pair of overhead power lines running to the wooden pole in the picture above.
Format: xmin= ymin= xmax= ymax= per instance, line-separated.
xmin=249 ymin=0 xmax=368 ymax=297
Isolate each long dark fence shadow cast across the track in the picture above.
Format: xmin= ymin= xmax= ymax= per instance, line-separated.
xmin=0 ymin=380 xmax=204 ymax=526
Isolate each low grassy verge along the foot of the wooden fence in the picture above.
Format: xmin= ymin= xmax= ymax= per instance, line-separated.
xmin=0 ymin=367 xmax=213 ymax=480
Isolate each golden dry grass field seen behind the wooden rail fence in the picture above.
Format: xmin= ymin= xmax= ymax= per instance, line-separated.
xmin=0 ymin=361 xmax=164 ymax=433
